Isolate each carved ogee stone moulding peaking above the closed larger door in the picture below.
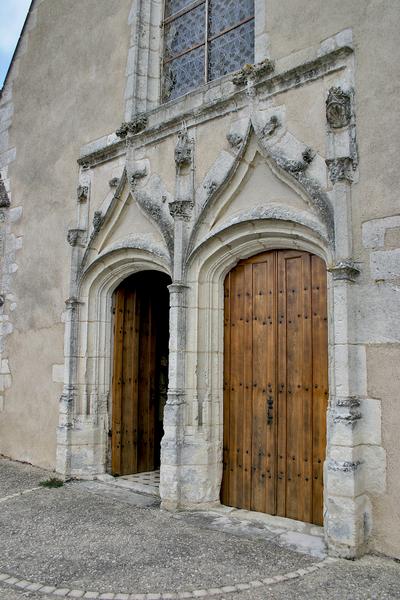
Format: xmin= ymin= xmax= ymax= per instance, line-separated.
xmin=187 ymin=107 xmax=335 ymax=257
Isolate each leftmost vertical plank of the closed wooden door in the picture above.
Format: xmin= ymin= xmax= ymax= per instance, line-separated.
xmin=221 ymin=273 xmax=232 ymax=506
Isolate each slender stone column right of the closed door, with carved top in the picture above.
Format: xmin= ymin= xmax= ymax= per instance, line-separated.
xmin=325 ymin=87 xmax=371 ymax=558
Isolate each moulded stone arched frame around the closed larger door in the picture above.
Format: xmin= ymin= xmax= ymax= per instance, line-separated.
xmin=180 ymin=219 xmax=374 ymax=557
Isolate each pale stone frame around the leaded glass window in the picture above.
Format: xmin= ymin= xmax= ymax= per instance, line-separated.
xmin=124 ymin=0 xmax=270 ymax=121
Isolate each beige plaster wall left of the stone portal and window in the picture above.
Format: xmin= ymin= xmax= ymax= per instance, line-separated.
xmin=0 ymin=0 xmax=131 ymax=468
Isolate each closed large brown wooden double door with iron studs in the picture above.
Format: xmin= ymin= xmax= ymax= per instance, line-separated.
xmin=221 ymin=250 xmax=328 ymax=524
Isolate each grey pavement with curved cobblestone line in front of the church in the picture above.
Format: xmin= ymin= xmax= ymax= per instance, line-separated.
xmin=0 ymin=459 xmax=400 ymax=600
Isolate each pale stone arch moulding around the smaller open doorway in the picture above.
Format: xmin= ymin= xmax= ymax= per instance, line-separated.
xmin=57 ymin=247 xmax=170 ymax=477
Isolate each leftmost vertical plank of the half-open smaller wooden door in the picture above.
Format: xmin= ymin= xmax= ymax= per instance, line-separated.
xmin=111 ymin=289 xmax=125 ymax=475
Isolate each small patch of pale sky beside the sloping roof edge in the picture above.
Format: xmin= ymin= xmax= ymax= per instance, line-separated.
xmin=0 ymin=0 xmax=31 ymax=87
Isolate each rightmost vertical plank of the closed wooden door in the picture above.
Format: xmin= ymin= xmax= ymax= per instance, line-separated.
xmin=311 ymin=256 xmax=328 ymax=525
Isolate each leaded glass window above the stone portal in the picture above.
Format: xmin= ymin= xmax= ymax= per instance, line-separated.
xmin=163 ymin=0 xmax=254 ymax=101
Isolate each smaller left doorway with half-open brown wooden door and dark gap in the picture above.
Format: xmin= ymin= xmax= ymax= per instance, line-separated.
xmin=111 ymin=271 xmax=170 ymax=475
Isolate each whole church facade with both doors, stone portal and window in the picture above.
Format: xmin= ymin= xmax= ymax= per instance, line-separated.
xmin=0 ymin=0 xmax=400 ymax=558
